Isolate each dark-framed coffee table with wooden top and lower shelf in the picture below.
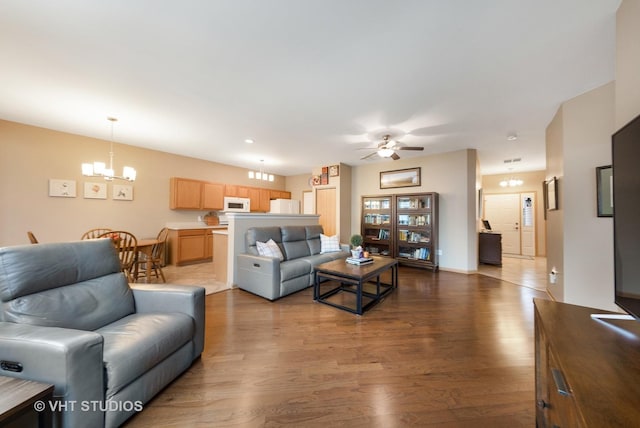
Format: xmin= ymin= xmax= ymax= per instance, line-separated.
xmin=313 ymin=257 xmax=398 ymax=315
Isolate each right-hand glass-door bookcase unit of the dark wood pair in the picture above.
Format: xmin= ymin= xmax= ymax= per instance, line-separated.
xmin=395 ymin=193 xmax=438 ymax=271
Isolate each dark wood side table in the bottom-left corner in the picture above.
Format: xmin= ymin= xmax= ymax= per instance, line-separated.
xmin=0 ymin=376 xmax=53 ymax=428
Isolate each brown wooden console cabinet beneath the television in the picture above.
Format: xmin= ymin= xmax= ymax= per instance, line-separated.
xmin=534 ymin=299 xmax=640 ymax=428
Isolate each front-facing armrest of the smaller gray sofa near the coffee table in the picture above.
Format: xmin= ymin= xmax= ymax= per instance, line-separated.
xmin=236 ymin=254 xmax=280 ymax=300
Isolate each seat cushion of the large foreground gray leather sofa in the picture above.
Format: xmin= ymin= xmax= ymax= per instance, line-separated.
xmin=96 ymin=312 xmax=195 ymax=399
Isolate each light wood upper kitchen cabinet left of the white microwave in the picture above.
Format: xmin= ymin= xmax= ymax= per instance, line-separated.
xmin=169 ymin=177 xmax=225 ymax=210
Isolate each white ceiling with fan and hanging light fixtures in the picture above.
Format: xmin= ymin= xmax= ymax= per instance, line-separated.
xmin=0 ymin=0 xmax=620 ymax=175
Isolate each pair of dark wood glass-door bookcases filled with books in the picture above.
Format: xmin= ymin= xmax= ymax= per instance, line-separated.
xmin=361 ymin=192 xmax=438 ymax=271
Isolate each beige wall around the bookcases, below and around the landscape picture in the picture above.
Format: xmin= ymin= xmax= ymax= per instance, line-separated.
xmin=351 ymin=149 xmax=478 ymax=273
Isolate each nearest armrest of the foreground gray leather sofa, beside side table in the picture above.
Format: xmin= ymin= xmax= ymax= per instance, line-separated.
xmin=0 ymin=322 xmax=104 ymax=427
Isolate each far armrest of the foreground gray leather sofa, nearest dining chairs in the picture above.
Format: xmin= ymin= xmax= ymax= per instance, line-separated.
xmin=130 ymin=284 xmax=205 ymax=360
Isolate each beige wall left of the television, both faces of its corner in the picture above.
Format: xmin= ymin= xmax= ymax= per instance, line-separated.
xmin=547 ymin=82 xmax=617 ymax=310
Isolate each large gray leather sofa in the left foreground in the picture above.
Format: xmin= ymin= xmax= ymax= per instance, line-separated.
xmin=0 ymin=239 xmax=205 ymax=428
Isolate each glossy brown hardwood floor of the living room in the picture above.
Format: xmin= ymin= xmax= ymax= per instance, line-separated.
xmin=126 ymin=267 xmax=548 ymax=428
